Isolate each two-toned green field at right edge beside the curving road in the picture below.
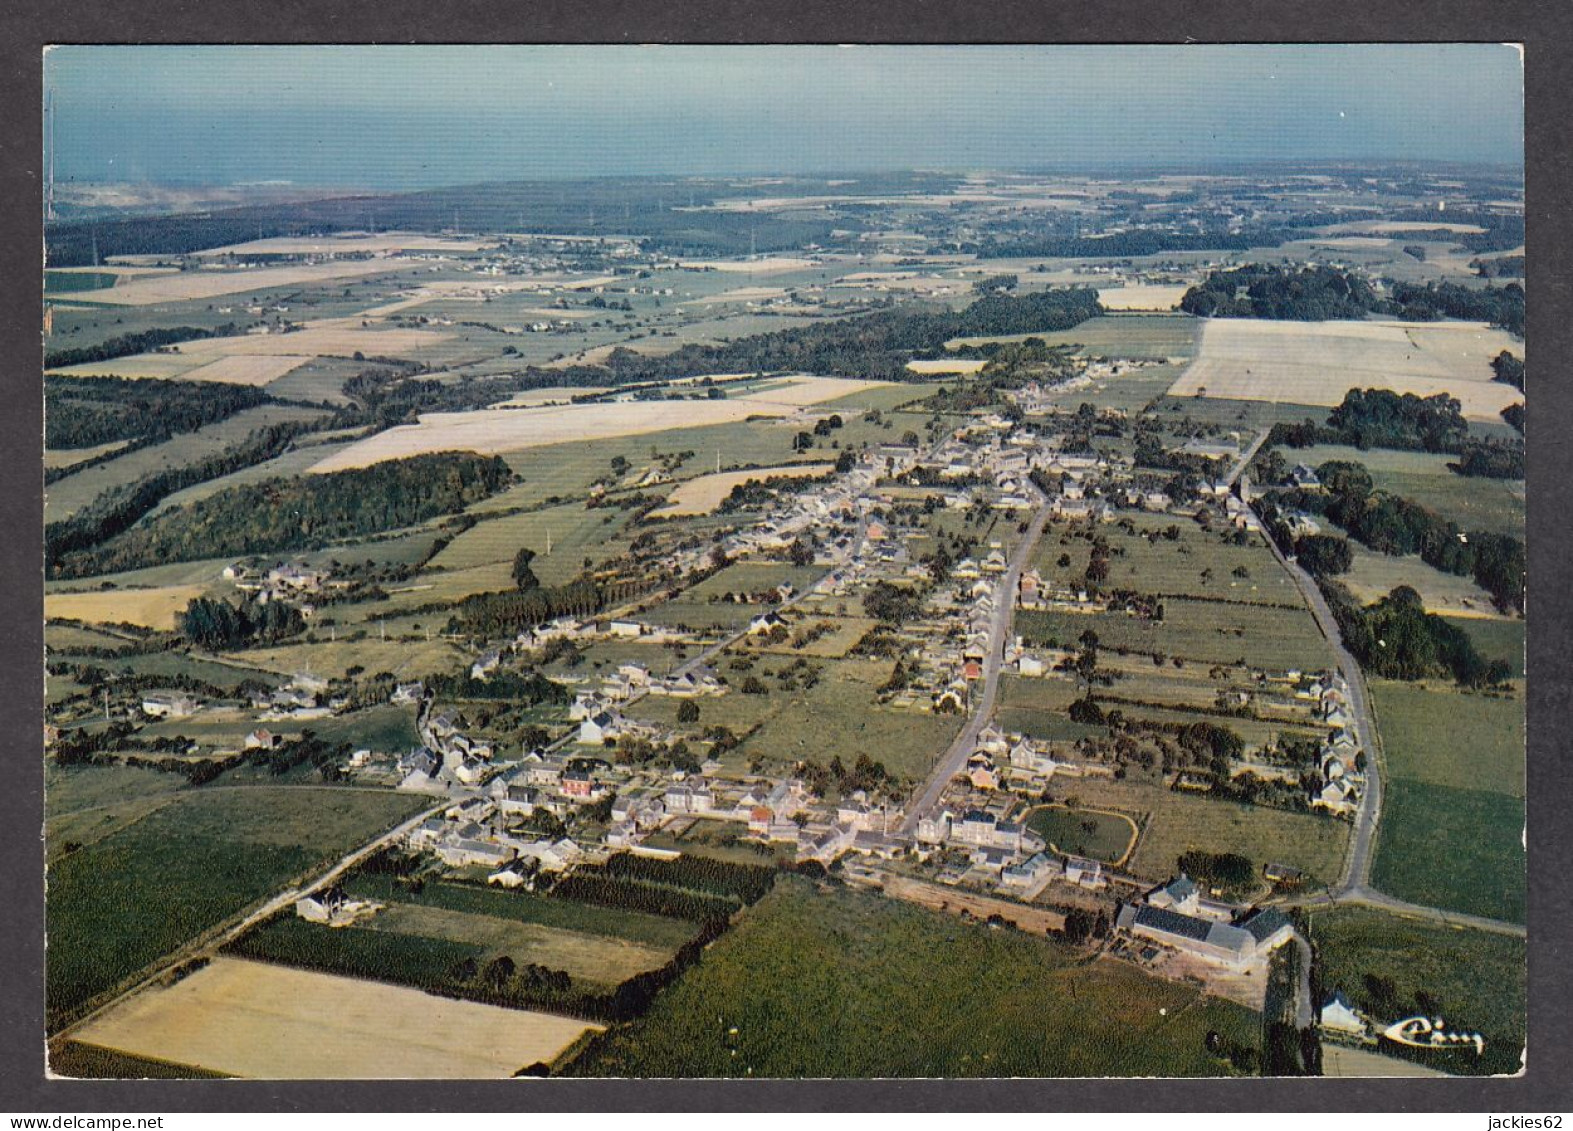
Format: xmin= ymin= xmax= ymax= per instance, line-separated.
xmin=1372 ymin=680 xmax=1526 ymax=922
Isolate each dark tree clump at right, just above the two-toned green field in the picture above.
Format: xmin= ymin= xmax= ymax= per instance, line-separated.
xmin=1321 ymin=582 xmax=1512 ymax=687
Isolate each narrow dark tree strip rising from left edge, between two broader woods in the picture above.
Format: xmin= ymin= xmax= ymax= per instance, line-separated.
xmin=44 ymin=423 xmax=313 ymax=577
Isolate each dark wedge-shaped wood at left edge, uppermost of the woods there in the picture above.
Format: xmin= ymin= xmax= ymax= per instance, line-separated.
xmin=44 ymin=374 xmax=274 ymax=450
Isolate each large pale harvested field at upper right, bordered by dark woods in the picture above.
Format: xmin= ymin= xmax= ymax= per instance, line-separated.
xmin=1169 ymin=318 xmax=1524 ymax=420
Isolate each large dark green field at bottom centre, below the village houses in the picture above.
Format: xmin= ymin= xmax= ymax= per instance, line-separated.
xmin=568 ymin=879 xmax=1258 ymax=1078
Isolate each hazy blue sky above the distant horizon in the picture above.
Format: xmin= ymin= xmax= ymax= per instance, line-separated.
xmin=44 ymin=44 xmax=1523 ymax=189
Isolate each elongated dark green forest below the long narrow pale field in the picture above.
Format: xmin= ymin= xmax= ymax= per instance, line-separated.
xmin=53 ymin=453 xmax=513 ymax=577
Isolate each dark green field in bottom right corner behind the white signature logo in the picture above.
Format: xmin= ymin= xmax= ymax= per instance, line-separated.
xmin=1310 ymin=908 xmax=1527 ymax=1076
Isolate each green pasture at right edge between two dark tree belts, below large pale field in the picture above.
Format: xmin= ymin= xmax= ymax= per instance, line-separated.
xmin=1284 ymin=444 xmax=1524 ymax=538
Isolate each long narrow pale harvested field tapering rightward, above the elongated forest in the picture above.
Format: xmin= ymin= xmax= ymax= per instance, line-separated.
xmin=311 ymin=378 xmax=889 ymax=473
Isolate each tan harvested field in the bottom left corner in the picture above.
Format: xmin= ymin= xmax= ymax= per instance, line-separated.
xmin=76 ymin=958 xmax=601 ymax=1079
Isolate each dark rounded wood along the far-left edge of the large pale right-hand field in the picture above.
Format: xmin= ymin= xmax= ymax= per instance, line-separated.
xmin=1180 ymin=264 xmax=1378 ymax=322
